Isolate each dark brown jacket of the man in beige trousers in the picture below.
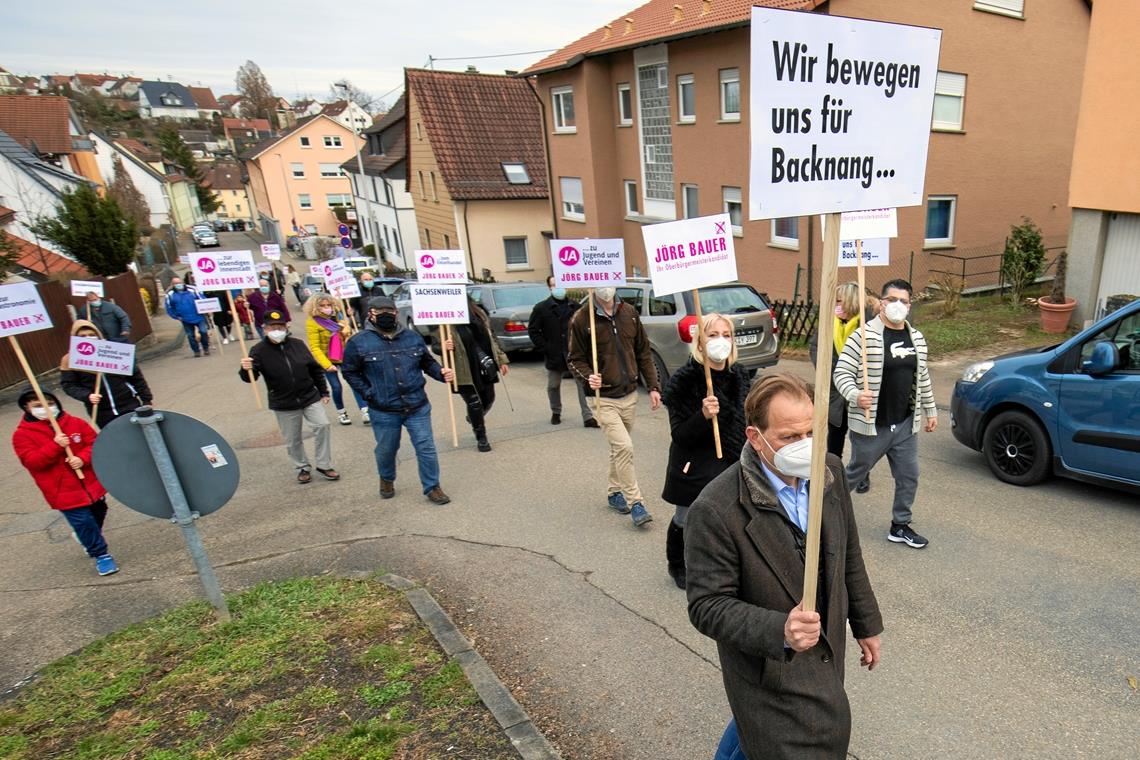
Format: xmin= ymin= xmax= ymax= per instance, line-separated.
xmin=568 ymin=299 xmax=661 ymax=399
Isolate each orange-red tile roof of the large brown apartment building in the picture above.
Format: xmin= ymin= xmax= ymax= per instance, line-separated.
xmin=523 ymin=0 xmax=824 ymax=74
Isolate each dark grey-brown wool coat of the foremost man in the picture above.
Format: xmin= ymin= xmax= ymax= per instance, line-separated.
xmin=685 ymin=446 xmax=882 ymax=760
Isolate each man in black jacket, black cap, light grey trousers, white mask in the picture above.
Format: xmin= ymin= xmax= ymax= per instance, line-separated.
xmin=237 ymin=309 xmax=341 ymax=483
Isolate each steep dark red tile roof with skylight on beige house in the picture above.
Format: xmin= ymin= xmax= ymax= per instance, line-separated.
xmin=404 ymin=68 xmax=549 ymax=201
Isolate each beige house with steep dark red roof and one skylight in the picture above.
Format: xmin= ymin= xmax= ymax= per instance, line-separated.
xmin=404 ymin=68 xmax=553 ymax=281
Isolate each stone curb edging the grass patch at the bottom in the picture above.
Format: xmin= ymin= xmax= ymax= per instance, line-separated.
xmin=362 ymin=571 xmax=562 ymax=760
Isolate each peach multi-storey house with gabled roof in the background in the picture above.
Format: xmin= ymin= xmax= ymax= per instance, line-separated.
xmin=241 ymin=114 xmax=360 ymax=243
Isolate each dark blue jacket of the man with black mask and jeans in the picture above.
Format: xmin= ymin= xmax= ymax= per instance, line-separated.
xmin=341 ymin=325 xmax=443 ymax=414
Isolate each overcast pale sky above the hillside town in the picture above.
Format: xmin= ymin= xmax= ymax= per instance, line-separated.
xmin=0 ymin=0 xmax=643 ymax=105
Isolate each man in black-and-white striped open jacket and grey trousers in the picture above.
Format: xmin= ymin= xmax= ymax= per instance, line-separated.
xmin=833 ymin=279 xmax=938 ymax=549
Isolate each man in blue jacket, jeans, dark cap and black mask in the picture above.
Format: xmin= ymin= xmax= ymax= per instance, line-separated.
xmin=341 ymin=295 xmax=455 ymax=505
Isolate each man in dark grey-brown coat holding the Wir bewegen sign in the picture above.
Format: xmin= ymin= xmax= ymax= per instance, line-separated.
xmin=685 ymin=375 xmax=882 ymax=760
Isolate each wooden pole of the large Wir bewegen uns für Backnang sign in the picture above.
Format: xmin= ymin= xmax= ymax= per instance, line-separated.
xmin=803 ymin=214 xmax=839 ymax=612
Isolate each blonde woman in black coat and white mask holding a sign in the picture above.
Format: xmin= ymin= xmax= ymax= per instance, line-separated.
xmin=661 ymin=314 xmax=751 ymax=588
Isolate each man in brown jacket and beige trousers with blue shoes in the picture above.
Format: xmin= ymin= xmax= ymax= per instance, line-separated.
xmin=569 ymin=287 xmax=661 ymax=528
